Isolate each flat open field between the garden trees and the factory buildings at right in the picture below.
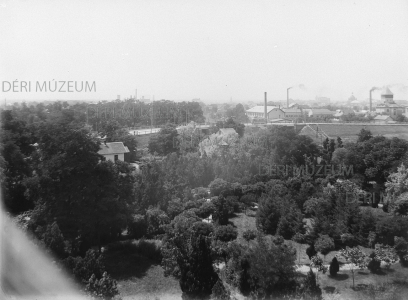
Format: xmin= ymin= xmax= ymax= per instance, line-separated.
xmin=301 ymin=124 xmax=408 ymax=142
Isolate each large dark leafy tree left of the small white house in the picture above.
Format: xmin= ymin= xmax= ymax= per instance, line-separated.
xmin=25 ymin=122 xmax=134 ymax=250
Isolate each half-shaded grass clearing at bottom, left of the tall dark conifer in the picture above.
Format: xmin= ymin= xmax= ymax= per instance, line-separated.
xmin=105 ymin=241 xmax=182 ymax=300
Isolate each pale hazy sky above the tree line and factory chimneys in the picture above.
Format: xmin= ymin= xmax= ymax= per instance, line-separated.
xmin=0 ymin=0 xmax=408 ymax=102
